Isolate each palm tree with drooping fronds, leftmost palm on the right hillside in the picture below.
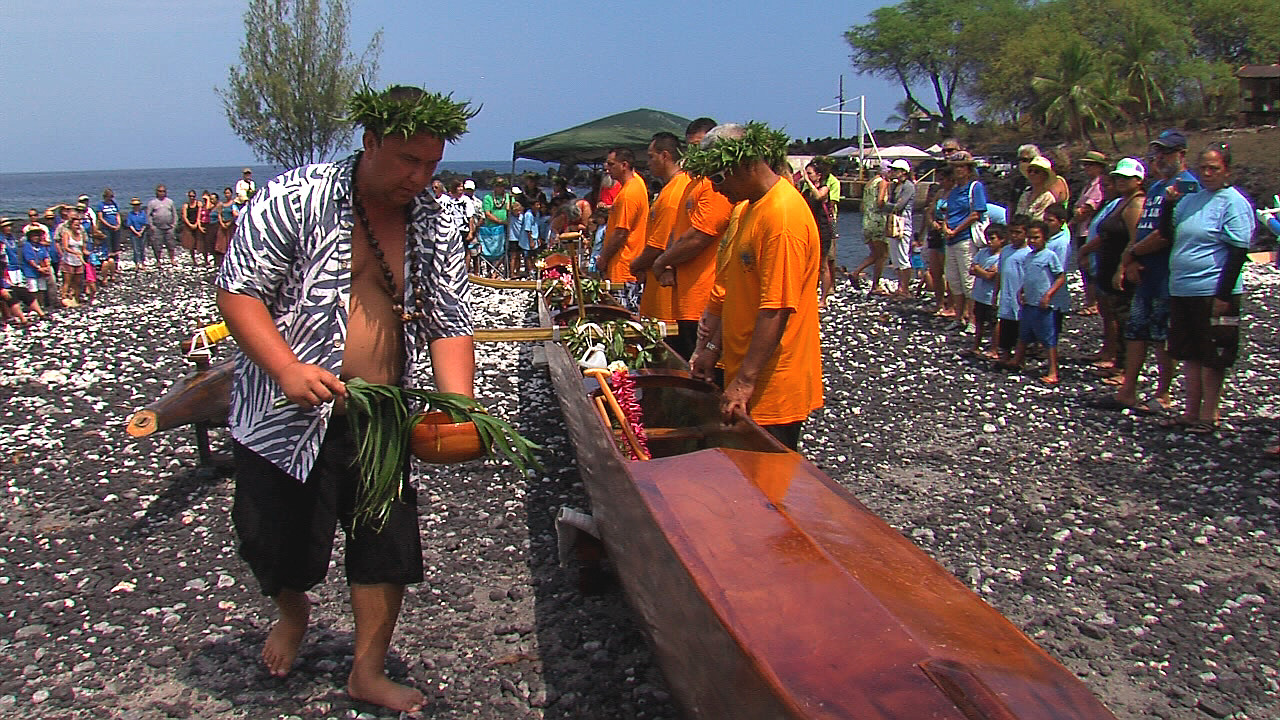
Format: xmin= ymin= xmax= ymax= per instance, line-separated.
xmin=1032 ymin=40 xmax=1116 ymax=147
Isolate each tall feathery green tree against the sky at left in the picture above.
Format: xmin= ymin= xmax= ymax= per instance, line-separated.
xmin=218 ymin=0 xmax=381 ymax=167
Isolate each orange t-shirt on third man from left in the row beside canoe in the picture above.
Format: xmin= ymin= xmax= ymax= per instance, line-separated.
xmin=671 ymin=178 xmax=732 ymax=320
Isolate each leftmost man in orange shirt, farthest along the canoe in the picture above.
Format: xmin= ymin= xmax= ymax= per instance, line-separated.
xmin=596 ymin=147 xmax=649 ymax=310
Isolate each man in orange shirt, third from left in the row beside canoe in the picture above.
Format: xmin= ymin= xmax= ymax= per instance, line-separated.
xmin=653 ymin=118 xmax=732 ymax=359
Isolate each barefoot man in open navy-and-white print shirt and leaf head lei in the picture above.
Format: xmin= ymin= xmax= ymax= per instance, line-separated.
xmin=218 ymin=86 xmax=475 ymax=712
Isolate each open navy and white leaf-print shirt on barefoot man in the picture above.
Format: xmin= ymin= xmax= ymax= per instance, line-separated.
xmin=216 ymin=155 xmax=474 ymax=480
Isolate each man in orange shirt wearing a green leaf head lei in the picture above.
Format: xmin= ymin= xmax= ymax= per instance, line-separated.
xmin=685 ymin=123 xmax=822 ymax=450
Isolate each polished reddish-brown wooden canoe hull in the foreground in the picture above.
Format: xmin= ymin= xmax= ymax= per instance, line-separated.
xmin=540 ymin=294 xmax=1115 ymax=720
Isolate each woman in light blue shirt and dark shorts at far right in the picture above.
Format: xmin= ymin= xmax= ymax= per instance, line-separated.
xmin=1162 ymin=142 xmax=1254 ymax=434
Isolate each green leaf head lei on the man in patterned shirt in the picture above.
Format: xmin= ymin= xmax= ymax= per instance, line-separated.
xmin=346 ymin=85 xmax=480 ymax=142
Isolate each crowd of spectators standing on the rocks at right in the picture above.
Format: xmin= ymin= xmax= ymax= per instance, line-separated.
xmin=851 ymin=128 xmax=1256 ymax=434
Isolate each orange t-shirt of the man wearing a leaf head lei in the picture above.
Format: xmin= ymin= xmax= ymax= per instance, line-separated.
xmin=710 ymin=182 xmax=822 ymax=425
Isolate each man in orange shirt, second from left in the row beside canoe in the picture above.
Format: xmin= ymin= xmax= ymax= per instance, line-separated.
xmin=631 ymin=132 xmax=692 ymax=326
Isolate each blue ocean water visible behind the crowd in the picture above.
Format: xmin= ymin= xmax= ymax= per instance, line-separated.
xmin=0 ymin=160 xmax=867 ymax=269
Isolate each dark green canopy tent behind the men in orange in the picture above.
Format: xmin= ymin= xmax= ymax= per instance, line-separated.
xmin=511 ymin=108 xmax=689 ymax=165
